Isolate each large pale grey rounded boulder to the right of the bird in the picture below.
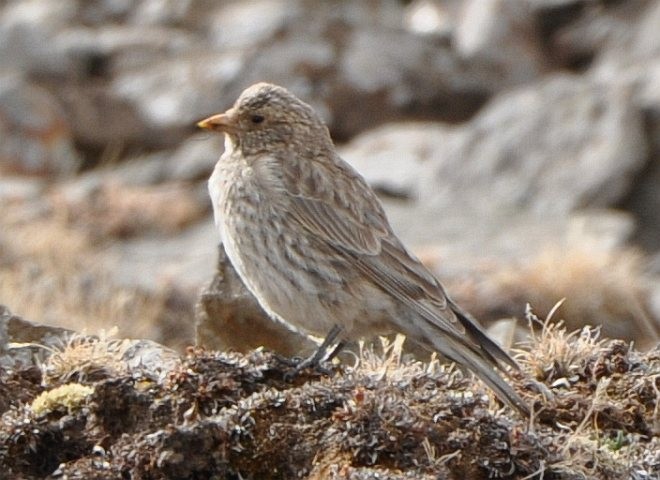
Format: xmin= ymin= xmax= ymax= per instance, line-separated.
xmin=420 ymin=75 xmax=647 ymax=215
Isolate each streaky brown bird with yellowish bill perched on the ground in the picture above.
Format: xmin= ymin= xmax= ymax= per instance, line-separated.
xmin=197 ymin=82 xmax=529 ymax=416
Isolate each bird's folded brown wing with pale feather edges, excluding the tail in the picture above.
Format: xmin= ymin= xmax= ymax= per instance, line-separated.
xmin=285 ymin=153 xmax=465 ymax=334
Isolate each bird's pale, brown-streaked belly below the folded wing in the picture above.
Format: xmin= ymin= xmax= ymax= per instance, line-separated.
xmin=219 ymin=195 xmax=390 ymax=337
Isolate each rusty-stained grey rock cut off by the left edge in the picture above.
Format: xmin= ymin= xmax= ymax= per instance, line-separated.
xmin=0 ymin=75 xmax=80 ymax=176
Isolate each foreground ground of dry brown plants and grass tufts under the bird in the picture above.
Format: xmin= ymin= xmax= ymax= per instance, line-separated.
xmin=0 ymin=312 xmax=660 ymax=480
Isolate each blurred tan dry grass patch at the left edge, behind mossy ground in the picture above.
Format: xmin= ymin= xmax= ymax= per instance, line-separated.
xmin=0 ymin=210 xmax=170 ymax=338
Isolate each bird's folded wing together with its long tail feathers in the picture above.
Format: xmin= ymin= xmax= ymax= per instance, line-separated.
xmin=274 ymin=158 xmax=528 ymax=414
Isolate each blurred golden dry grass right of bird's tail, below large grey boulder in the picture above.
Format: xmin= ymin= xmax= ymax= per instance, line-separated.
xmin=488 ymin=248 xmax=660 ymax=348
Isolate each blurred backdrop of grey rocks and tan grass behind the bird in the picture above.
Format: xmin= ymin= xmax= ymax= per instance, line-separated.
xmin=0 ymin=0 xmax=660 ymax=349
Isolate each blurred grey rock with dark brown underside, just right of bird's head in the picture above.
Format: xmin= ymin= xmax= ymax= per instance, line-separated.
xmin=328 ymin=28 xmax=490 ymax=137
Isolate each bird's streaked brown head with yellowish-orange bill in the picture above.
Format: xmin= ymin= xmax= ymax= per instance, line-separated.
xmin=197 ymin=83 xmax=332 ymax=153
